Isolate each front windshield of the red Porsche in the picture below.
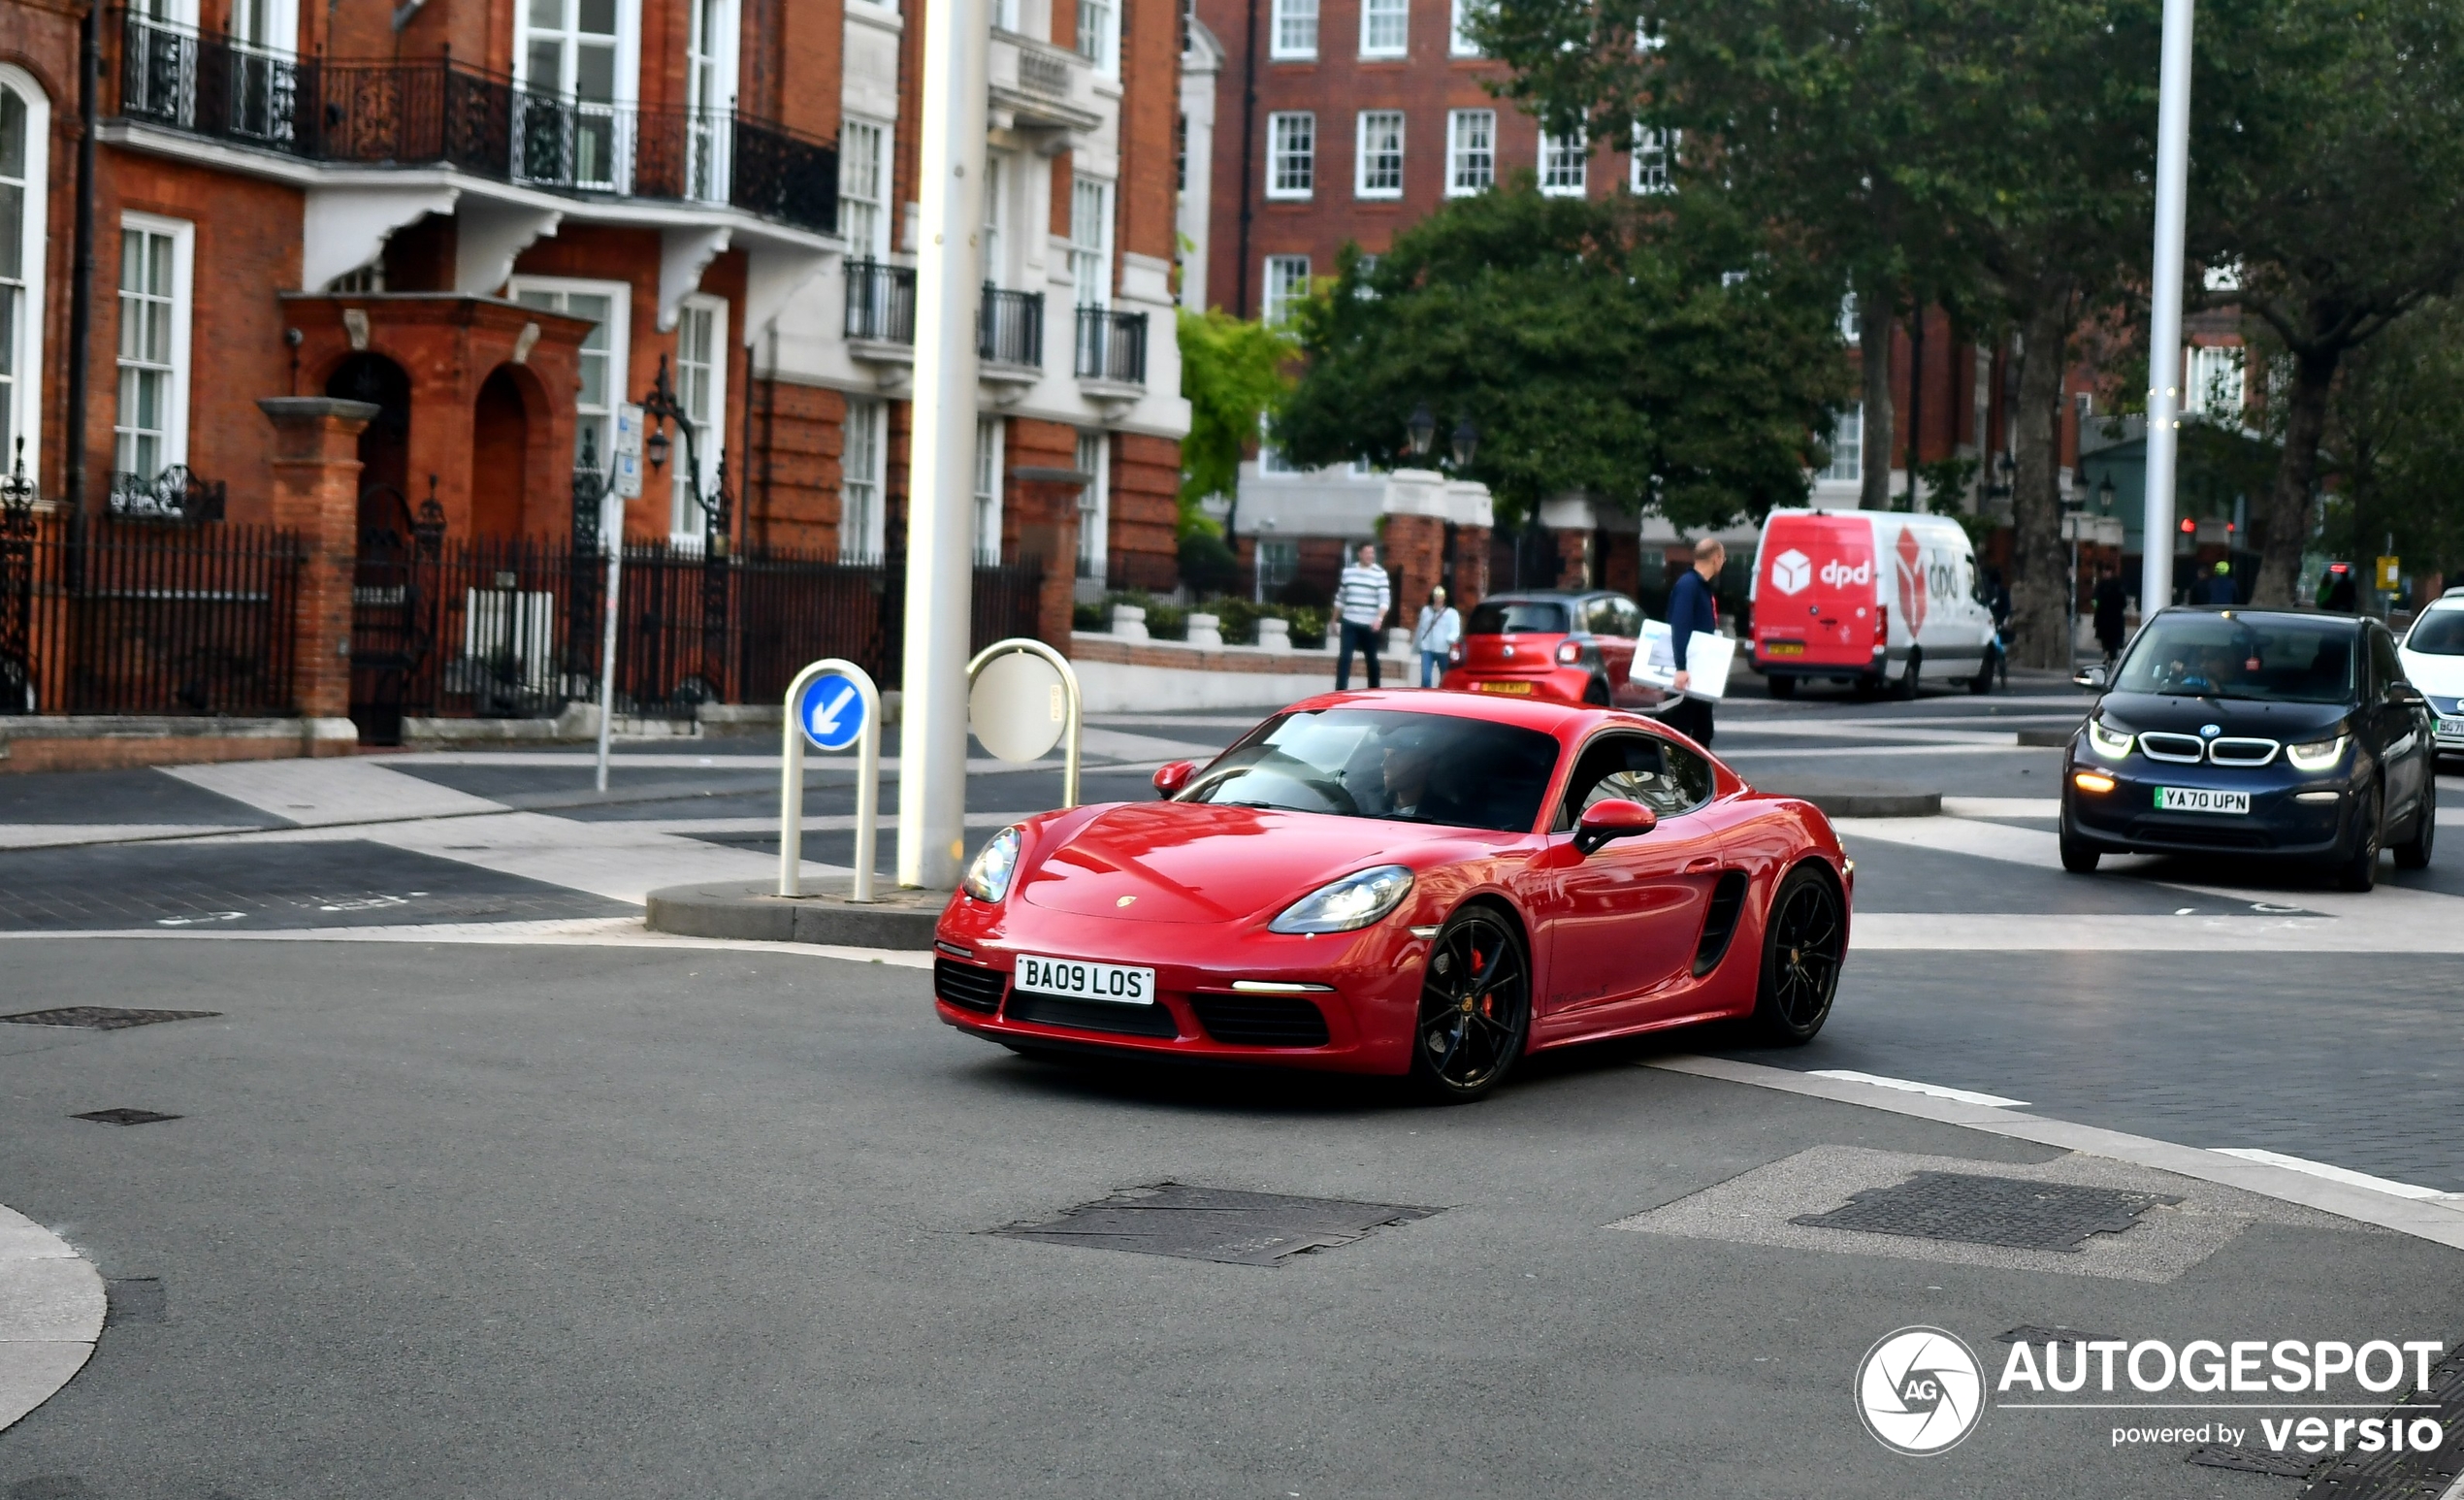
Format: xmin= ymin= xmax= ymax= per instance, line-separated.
xmin=1178 ymin=709 xmax=1557 ymax=832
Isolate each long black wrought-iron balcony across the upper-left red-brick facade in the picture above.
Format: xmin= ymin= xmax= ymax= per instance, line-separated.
xmin=115 ymin=13 xmax=838 ymax=234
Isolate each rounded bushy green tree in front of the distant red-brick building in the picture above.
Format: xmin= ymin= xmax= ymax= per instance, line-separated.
xmin=1274 ymin=178 xmax=1848 ymax=527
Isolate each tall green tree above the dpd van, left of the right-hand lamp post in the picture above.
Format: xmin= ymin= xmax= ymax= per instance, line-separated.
xmin=1478 ymin=0 xmax=2156 ymax=665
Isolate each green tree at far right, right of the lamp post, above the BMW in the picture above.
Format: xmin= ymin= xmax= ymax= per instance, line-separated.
xmin=2190 ymin=0 xmax=2464 ymax=605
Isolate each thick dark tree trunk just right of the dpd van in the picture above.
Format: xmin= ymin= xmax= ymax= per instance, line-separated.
xmin=2011 ymin=276 xmax=2075 ymax=672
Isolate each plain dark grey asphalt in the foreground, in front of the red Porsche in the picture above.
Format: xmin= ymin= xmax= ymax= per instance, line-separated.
xmin=0 ymin=941 xmax=2464 ymax=1500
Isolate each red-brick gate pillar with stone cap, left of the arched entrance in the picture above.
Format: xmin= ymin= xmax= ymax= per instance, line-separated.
xmin=256 ymin=397 xmax=377 ymax=738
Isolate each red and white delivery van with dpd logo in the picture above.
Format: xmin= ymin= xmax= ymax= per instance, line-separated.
xmin=1747 ymin=509 xmax=1994 ymax=697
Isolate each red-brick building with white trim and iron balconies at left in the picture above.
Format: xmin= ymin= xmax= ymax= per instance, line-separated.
xmin=0 ymin=0 xmax=1187 ymax=573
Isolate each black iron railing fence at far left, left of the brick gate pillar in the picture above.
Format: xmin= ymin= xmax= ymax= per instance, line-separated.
xmin=0 ymin=505 xmax=301 ymax=717
